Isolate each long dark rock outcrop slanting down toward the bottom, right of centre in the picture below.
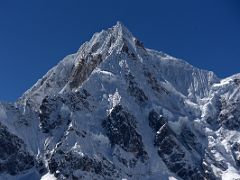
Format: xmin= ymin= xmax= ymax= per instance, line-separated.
xmin=149 ymin=110 xmax=204 ymax=179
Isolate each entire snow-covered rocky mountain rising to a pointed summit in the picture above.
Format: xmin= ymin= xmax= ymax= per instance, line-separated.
xmin=0 ymin=22 xmax=240 ymax=180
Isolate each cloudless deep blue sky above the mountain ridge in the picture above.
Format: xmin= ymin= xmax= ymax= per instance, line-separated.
xmin=0 ymin=0 xmax=240 ymax=101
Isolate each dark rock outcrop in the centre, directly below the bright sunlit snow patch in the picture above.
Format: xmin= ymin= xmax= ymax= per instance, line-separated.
xmin=102 ymin=105 xmax=147 ymax=161
